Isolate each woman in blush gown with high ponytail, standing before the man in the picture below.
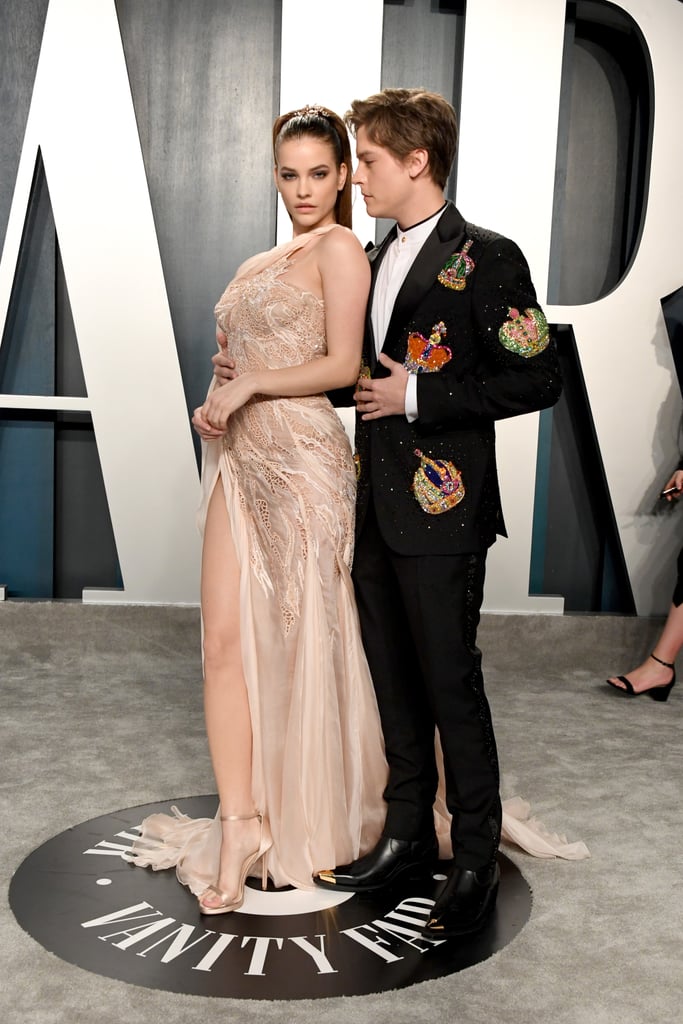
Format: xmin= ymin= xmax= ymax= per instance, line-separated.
xmin=135 ymin=106 xmax=386 ymax=914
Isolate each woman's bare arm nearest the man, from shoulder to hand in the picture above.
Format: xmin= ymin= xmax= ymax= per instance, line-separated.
xmin=201 ymin=228 xmax=370 ymax=430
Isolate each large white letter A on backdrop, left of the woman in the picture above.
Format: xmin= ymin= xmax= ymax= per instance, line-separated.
xmin=0 ymin=0 xmax=200 ymax=603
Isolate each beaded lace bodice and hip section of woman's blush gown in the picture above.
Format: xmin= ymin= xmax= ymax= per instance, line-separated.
xmin=216 ymin=253 xmax=355 ymax=633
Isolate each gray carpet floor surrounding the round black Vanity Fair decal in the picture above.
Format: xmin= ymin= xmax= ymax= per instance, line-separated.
xmin=0 ymin=602 xmax=683 ymax=1024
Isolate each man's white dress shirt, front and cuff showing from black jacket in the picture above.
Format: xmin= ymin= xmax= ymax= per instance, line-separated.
xmin=370 ymin=206 xmax=445 ymax=423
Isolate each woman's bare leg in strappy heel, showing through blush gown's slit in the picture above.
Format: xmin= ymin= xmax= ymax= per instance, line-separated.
xmin=200 ymin=477 xmax=263 ymax=913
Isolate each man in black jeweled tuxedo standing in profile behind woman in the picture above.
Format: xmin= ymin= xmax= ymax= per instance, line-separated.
xmin=315 ymin=89 xmax=561 ymax=939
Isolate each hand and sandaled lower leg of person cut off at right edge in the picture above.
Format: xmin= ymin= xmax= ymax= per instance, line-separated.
xmin=607 ymin=464 xmax=683 ymax=703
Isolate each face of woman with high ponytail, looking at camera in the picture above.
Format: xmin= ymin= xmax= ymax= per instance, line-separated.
xmin=274 ymin=135 xmax=346 ymax=234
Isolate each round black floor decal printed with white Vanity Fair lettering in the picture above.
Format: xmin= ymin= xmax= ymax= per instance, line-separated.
xmin=9 ymin=796 xmax=531 ymax=999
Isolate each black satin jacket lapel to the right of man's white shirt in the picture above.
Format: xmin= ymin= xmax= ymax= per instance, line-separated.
xmin=384 ymin=205 xmax=465 ymax=348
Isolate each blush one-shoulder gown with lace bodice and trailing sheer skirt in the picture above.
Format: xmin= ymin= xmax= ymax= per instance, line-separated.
xmin=132 ymin=228 xmax=583 ymax=895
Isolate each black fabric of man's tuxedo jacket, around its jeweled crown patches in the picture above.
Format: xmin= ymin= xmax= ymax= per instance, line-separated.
xmin=355 ymin=203 xmax=561 ymax=555
